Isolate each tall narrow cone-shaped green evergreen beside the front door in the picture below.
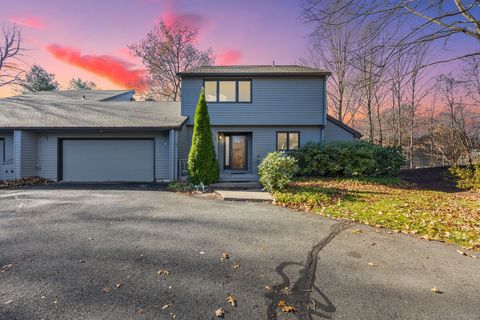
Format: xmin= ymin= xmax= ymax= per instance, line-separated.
xmin=188 ymin=89 xmax=219 ymax=185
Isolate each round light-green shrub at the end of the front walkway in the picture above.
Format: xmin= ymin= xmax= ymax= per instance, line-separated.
xmin=258 ymin=152 xmax=298 ymax=192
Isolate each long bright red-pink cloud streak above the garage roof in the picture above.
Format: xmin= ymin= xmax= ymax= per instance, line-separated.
xmin=46 ymin=44 xmax=145 ymax=91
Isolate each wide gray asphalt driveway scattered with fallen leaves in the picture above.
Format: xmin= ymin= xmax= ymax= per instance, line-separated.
xmin=0 ymin=185 xmax=480 ymax=320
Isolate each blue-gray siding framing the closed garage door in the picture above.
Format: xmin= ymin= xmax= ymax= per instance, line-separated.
xmin=33 ymin=132 xmax=169 ymax=181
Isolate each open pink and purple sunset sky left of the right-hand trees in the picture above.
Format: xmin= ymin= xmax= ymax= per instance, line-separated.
xmin=0 ymin=0 xmax=311 ymax=97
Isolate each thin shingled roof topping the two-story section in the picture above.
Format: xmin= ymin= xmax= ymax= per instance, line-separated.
xmin=178 ymin=65 xmax=330 ymax=77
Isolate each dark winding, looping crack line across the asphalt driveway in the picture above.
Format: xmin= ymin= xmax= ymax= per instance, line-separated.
xmin=265 ymin=222 xmax=349 ymax=320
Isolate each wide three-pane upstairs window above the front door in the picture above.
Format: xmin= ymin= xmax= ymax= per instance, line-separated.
xmin=204 ymin=80 xmax=252 ymax=103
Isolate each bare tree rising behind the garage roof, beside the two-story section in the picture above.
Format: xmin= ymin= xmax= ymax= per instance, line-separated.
xmin=129 ymin=20 xmax=214 ymax=101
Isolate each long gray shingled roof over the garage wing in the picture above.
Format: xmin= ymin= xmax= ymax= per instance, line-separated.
xmin=0 ymin=93 xmax=187 ymax=129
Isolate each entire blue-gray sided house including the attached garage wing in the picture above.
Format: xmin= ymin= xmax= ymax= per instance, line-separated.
xmin=0 ymin=66 xmax=360 ymax=182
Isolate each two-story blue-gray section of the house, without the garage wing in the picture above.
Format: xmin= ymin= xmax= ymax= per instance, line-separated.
xmin=179 ymin=65 xmax=360 ymax=181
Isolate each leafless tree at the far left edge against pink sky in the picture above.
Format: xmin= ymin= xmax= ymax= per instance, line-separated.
xmin=0 ymin=25 xmax=23 ymax=87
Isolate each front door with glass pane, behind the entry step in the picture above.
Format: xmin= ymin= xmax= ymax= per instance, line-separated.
xmin=225 ymin=134 xmax=248 ymax=170
